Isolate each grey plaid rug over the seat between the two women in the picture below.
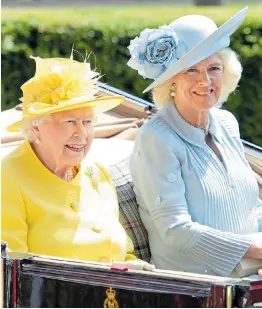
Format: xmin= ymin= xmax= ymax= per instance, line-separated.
xmin=107 ymin=157 xmax=151 ymax=262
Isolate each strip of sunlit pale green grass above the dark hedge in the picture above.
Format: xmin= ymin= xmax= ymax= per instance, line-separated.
xmin=2 ymin=4 xmax=262 ymax=27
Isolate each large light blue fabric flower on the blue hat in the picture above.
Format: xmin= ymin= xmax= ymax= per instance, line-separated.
xmin=127 ymin=25 xmax=187 ymax=79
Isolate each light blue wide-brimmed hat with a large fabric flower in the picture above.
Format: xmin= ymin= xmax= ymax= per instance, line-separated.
xmin=127 ymin=7 xmax=248 ymax=93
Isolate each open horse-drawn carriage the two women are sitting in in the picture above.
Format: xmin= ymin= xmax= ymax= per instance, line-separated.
xmin=1 ymin=85 xmax=262 ymax=308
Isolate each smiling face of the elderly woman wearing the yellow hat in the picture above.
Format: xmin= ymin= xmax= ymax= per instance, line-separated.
xmin=33 ymin=107 xmax=94 ymax=166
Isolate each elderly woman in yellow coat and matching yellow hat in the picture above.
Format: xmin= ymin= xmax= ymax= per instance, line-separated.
xmin=2 ymin=57 xmax=153 ymax=270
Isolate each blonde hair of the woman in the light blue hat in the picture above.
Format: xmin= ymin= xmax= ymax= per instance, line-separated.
xmin=152 ymin=48 xmax=242 ymax=108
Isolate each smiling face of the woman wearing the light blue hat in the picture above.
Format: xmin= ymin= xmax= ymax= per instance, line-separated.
xmin=173 ymin=54 xmax=223 ymax=111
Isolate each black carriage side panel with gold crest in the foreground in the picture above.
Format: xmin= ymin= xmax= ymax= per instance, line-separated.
xmin=1 ymin=254 xmax=262 ymax=308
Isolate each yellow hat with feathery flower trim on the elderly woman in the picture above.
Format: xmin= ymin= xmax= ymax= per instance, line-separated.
xmin=7 ymin=56 xmax=124 ymax=132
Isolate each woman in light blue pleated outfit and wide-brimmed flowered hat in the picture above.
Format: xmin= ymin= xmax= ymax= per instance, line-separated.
xmin=128 ymin=9 xmax=262 ymax=276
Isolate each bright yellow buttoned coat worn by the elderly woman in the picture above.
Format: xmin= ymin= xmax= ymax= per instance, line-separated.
xmin=2 ymin=141 xmax=136 ymax=262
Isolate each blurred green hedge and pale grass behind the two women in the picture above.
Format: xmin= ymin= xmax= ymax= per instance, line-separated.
xmin=2 ymin=4 xmax=262 ymax=146
